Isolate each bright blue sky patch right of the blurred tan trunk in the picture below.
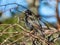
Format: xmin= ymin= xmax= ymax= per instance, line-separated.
xmin=38 ymin=0 xmax=60 ymax=23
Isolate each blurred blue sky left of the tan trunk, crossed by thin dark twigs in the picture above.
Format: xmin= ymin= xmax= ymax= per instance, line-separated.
xmin=0 ymin=0 xmax=28 ymax=21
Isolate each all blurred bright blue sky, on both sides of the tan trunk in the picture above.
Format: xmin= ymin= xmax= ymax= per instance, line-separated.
xmin=0 ymin=0 xmax=60 ymax=23
